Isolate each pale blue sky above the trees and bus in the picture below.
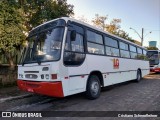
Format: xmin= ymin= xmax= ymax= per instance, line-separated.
xmin=67 ymin=0 xmax=160 ymax=49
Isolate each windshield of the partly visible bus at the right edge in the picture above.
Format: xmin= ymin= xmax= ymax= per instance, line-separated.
xmin=147 ymin=51 xmax=159 ymax=65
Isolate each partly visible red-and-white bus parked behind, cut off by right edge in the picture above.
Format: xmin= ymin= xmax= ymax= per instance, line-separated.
xmin=147 ymin=50 xmax=160 ymax=72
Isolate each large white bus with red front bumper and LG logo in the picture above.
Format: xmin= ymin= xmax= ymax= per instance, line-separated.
xmin=17 ymin=17 xmax=149 ymax=99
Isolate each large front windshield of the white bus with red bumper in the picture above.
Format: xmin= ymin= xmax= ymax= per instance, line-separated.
xmin=21 ymin=23 xmax=64 ymax=64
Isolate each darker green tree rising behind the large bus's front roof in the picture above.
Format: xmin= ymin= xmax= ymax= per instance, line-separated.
xmin=19 ymin=0 xmax=74 ymax=30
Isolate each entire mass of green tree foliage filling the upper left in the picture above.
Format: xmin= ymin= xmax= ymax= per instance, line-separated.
xmin=0 ymin=0 xmax=73 ymax=66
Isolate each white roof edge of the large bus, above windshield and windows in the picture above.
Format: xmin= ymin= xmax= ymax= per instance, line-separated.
xmin=30 ymin=17 xmax=146 ymax=49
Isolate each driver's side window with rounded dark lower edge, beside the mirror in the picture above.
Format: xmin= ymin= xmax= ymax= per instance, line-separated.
xmin=64 ymin=26 xmax=85 ymax=65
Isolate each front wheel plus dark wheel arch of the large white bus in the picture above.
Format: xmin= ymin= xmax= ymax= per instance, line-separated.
xmin=85 ymin=71 xmax=103 ymax=100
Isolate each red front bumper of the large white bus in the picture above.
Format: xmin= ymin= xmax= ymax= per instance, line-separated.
xmin=17 ymin=80 xmax=64 ymax=97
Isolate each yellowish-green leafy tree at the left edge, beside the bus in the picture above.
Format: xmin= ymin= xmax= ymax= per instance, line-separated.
xmin=0 ymin=0 xmax=25 ymax=68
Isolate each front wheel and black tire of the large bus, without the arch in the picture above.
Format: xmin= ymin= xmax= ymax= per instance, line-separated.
xmin=86 ymin=75 xmax=101 ymax=100
